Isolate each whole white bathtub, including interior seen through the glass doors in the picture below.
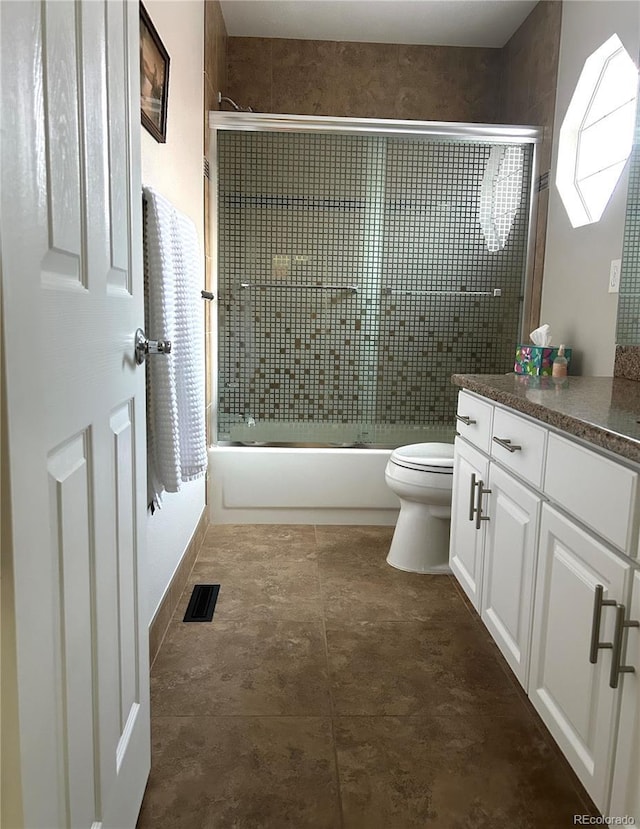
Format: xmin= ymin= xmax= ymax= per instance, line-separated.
xmin=208 ymin=421 xmax=455 ymax=526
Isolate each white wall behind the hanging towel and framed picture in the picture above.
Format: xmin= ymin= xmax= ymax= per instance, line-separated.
xmin=142 ymin=0 xmax=205 ymax=621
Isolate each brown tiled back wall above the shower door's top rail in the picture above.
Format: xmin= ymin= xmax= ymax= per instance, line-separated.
xmin=227 ymin=37 xmax=501 ymax=123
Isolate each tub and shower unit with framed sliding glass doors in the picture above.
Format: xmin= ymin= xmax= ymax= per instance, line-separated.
xmin=210 ymin=112 xmax=540 ymax=540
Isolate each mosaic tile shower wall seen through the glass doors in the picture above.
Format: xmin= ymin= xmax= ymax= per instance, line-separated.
xmin=218 ymin=131 xmax=531 ymax=440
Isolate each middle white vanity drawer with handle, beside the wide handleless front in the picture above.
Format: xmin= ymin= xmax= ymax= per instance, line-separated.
xmin=491 ymin=408 xmax=547 ymax=488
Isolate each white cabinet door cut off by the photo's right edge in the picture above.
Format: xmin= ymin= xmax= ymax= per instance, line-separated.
xmin=609 ymin=571 xmax=640 ymax=823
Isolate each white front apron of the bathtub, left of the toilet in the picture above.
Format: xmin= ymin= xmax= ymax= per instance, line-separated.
xmin=208 ymin=445 xmax=400 ymax=526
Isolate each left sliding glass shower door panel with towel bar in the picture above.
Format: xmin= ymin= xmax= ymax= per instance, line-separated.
xmin=218 ymin=132 xmax=385 ymax=445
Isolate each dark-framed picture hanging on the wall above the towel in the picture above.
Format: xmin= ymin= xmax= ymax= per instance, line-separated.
xmin=140 ymin=3 xmax=169 ymax=144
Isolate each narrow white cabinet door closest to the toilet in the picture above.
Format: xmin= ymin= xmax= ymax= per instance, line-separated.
xmin=449 ymin=437 xmax=489 ymax=611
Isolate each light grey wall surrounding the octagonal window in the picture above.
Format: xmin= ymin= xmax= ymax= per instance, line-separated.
xmin=541 ymin=0 xmax=640 ymax=376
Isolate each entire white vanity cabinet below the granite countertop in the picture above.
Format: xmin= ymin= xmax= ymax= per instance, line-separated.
xmin=450 ymin=391 xmax=640 ymax=822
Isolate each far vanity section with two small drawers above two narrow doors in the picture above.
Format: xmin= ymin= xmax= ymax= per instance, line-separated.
xmin=449 ymin=392 xmax=546 ymax=688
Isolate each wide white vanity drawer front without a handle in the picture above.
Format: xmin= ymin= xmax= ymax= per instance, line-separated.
xmin=544 ymin=434 xmax=638 ymax=554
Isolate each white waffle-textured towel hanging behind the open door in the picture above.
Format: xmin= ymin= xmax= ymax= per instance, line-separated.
xmin=144 ymin=187 xmax=207 ymax=504
